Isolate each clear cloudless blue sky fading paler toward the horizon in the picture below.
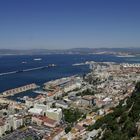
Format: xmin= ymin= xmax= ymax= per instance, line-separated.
xmin=0 ymin=0 xmax=140 ymax=49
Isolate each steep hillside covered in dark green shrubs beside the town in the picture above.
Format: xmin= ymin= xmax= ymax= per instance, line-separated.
xmin=89 ymin=82 xmax=140 ymax=140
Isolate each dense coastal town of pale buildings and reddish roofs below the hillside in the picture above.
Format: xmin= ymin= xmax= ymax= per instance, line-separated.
xmin=0 ymin=61 xmax=140 ymax=140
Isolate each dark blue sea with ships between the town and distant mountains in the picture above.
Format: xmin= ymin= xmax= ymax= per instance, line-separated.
xmin=0 ymin=54 xmax=140 ymax=98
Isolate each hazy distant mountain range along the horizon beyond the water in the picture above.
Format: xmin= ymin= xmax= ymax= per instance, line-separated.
xmin=0 ymin=48 xmax=140 ymax=55
